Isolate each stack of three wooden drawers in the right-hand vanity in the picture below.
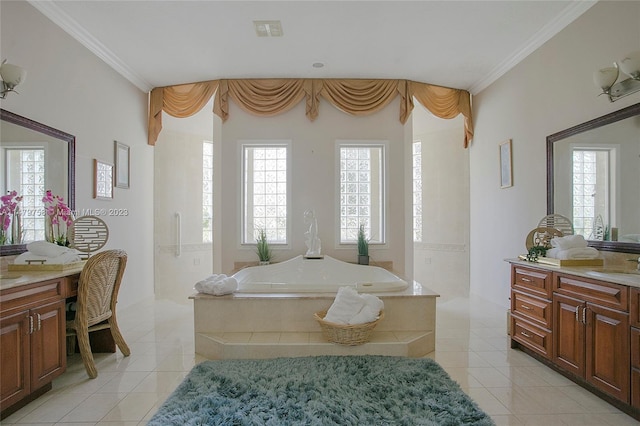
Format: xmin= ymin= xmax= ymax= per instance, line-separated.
xmin=511 ymin=265 xmax=553 ymax=359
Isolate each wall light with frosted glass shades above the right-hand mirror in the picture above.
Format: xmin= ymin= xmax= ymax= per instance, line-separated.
xmin=593 ymin=51 xmax=640 ymax=102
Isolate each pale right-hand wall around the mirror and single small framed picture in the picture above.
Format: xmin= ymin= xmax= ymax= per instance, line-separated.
xmin=470 ymin=1 xmax=640 ymax=306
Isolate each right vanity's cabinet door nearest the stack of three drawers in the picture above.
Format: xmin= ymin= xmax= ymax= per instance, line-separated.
xmin=553 ymin=293 xmax=586 ymax=377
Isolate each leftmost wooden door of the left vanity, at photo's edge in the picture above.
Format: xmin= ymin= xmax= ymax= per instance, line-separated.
xmin=0 ymin=311 xmax=30 ymax=409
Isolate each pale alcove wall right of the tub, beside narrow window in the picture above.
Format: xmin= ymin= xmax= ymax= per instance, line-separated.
xmin=413 ymin=113 xmax=469 ymax=300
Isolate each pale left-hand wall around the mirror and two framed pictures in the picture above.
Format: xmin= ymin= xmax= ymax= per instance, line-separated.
xmin=0 ymin=1 xmax=153 ymax=307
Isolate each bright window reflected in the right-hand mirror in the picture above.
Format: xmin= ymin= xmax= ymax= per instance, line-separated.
xmin=572 ymin=148 xmax=615 ymax=239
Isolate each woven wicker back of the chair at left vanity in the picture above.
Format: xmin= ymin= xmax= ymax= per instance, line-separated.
xmin=75 ymin=250 xmax=127 ymax=328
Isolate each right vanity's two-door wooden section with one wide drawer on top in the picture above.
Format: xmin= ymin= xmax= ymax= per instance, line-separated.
xmin=553 ymin=273 xmax=630 ymax=403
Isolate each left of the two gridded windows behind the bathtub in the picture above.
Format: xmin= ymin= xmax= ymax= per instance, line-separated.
xmin=242 ymin=142 xmax=289 ymax=244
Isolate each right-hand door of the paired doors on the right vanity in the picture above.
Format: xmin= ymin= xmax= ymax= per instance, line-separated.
xmin=585 ymin=304 xmax=630 ymax=403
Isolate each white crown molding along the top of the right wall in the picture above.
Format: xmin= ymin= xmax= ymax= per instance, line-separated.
xmin=469 ymin=0 xmax=598 ymax=95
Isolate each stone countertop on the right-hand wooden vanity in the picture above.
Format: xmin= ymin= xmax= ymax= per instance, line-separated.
xmin=505 ymin=258 xmax=640 ymax=288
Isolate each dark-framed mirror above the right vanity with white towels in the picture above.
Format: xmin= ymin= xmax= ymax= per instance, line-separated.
xmin=547 ymin=103 xmax=640 ymax=253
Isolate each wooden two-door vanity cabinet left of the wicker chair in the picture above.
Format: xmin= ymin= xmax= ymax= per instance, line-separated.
xmin=0 ymin=278 xmax=66 ymax=417
